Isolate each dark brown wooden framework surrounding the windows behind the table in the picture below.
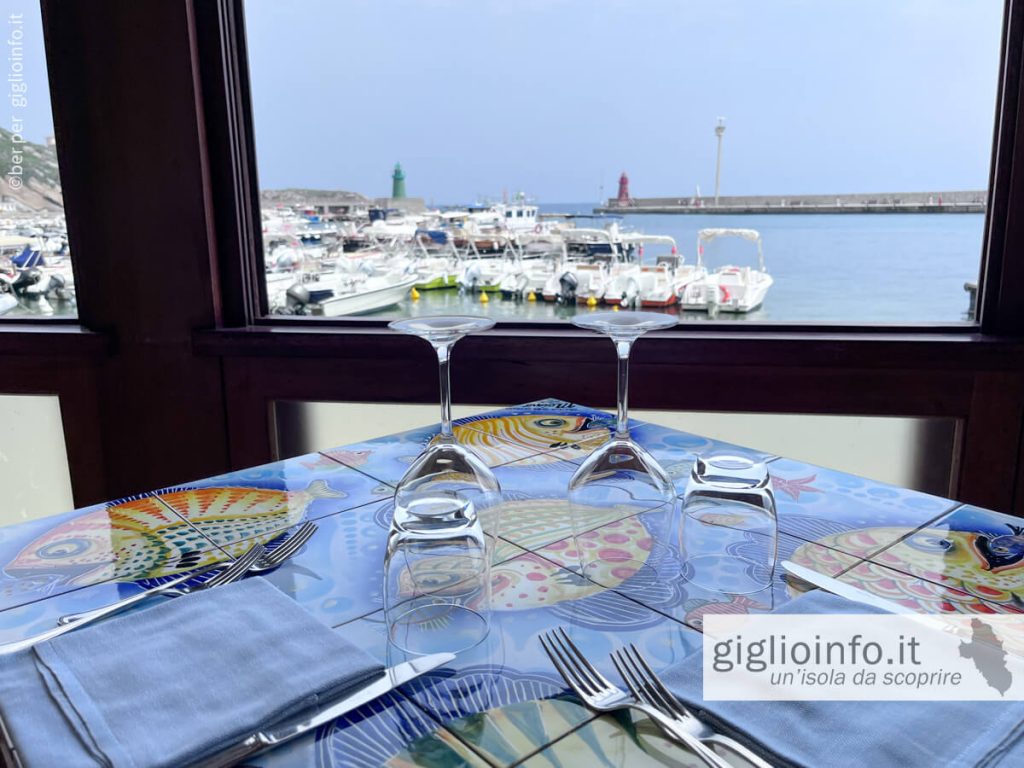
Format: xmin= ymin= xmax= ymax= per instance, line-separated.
xmin=0 ymin=0 xmax=1024 ymax=513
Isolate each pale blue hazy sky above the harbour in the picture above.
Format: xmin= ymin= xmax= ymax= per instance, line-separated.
xmin=14 ymin=0 xmax=1002 ymax=204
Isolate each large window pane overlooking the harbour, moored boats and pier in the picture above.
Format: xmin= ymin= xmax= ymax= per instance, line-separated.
xmin=246 ymin=0 xmax=1002 ymax=325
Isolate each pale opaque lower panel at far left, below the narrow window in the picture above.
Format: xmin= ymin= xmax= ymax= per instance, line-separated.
xmin=0 ymin=394 xmax=75 ymax=526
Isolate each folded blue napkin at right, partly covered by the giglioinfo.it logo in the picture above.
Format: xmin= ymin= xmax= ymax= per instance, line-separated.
xmin=663 ymin=590 xmax=1024 ymax=768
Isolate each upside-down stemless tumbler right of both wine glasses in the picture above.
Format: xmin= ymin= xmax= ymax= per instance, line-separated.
xmin=680 ymin=454 xmax=778 ymax=595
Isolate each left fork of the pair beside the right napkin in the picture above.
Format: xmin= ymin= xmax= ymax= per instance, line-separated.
xmin=540 ymin=628 xmax=731 ymax=768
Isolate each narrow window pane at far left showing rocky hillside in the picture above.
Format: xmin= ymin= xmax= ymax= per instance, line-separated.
xmin=0 ymin=0 xmax=77 ymax=318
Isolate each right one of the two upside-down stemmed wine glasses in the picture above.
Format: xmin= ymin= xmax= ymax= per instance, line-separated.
xmin=568 ymin=311 xmax=679 ymax=583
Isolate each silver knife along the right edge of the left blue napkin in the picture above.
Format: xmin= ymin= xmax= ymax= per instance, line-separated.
xmin=195 ymin=653 xmax=455 ymax=768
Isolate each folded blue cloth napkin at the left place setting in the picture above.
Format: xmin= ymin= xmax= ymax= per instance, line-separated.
xmin=0 ymin=579 xmax=382 ymax=768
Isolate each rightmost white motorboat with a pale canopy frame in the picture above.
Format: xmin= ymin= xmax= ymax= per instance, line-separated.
xmin=677 ymin=228 xmax=774 ymax=314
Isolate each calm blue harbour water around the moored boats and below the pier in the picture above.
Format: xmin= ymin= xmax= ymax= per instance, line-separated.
xmin=375 ymin=204 xmax=984 ymax=324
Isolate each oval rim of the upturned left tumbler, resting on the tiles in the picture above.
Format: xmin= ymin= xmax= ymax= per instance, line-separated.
xmin=387 ymin=603 xmax=490 ymax=655
